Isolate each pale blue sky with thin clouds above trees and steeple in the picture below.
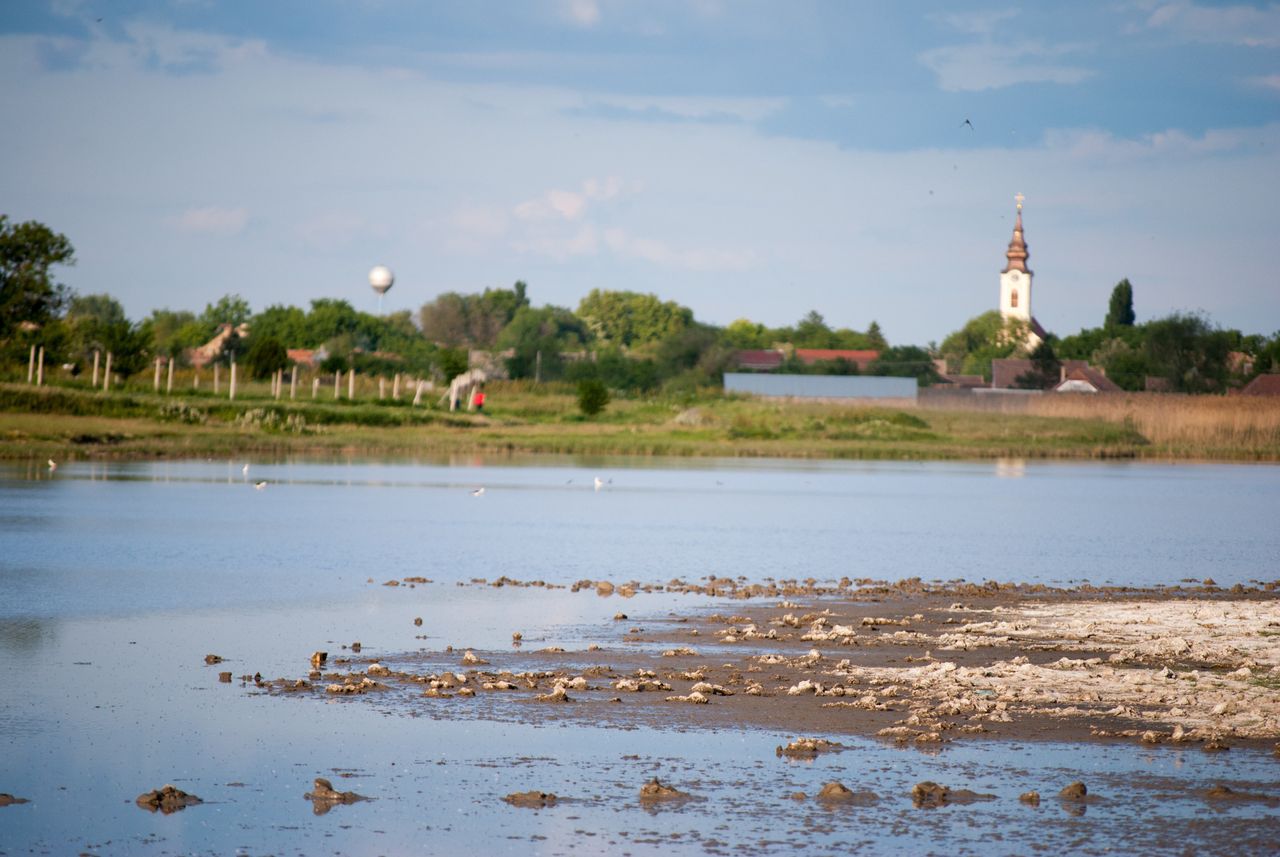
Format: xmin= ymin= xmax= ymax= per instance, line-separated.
xmin=0 ymin=0 xmax=1280 ymax=345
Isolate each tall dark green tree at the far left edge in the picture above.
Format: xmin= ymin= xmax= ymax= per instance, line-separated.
xmin=0 ymin=215 xmax=76 ymax=342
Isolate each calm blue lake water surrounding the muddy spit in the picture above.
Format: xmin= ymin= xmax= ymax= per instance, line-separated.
xmin=0 ymin=458 xmax=1280 ymax=854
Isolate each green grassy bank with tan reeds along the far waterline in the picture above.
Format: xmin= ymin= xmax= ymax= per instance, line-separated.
xmin=0 ymin=382 xmax=1280 ymax=460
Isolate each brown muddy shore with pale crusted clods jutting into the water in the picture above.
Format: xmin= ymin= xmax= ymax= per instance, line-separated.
xmin=243 ymin=578 xmax=1280 ymax=751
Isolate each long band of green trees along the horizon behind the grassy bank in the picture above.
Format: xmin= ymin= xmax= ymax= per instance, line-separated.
xmin=0 ymin=215 xmax=1280 ymax=393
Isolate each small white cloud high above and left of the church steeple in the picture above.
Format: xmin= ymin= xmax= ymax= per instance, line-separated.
xmin=918 ymin=42 xmax=1093 ymax=92
